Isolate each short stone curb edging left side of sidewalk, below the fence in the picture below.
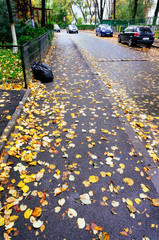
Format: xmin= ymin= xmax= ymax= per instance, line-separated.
xmin=0 ymin=89 xmax=31 ymax=154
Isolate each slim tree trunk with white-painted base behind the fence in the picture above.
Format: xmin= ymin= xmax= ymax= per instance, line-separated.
xmin=6 ymin=0 xmax=18 ymax=53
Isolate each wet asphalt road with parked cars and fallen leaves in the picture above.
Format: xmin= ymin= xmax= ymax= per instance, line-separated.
xmin=65 ymin=29 xmax=159 ymax=161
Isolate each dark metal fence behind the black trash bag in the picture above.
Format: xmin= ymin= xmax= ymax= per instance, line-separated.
xmin=1 ymin=30 xmax=53 ymax=88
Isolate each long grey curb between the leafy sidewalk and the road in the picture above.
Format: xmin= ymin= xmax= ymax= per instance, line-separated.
xmin=72 ymin=35 xmax=159 ymax=194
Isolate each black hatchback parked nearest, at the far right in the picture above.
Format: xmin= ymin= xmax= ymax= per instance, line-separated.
xmin=118 ymin=26 xmax=155 ymax=47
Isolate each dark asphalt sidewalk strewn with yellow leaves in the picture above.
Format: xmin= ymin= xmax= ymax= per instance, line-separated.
xmin=0 ymin=33 xmax=159 ymax=240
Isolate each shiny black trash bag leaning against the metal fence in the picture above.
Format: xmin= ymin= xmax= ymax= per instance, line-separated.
xmin=32 ymin=62 xmax=54 ymax=83
